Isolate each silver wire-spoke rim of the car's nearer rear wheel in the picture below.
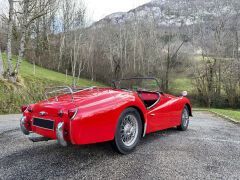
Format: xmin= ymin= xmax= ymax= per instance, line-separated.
xmin=120 ymin=115 xmax=138 ymax=146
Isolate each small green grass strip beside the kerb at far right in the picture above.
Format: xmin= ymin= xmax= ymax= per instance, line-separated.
xmin=209 ymin=108 xmax=240 ymax=122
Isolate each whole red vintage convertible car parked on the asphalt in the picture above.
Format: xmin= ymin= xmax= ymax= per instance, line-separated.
xmin=20 ymin=78 xmax=192 ymax=154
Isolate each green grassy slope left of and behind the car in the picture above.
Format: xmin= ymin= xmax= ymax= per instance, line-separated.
xmin=0 ymin=54 xmax=103 ymax=114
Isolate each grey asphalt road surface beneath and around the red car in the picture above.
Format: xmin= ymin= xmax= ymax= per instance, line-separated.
xmin=0 ymin=112 xmax=240 ymax=180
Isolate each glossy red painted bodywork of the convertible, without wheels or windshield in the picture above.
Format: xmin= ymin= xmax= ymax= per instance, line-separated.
xmin=21 ymin=85 xmax=191 ymax=145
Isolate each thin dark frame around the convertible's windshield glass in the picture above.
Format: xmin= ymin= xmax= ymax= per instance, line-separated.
xmin=112 ymin=77 xmax=161 ymax=92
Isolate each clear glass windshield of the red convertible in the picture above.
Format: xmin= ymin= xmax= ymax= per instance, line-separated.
xmin=114 ymin=78 xmax=159 ymax=91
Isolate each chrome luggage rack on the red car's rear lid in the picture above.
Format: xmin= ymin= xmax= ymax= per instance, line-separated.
xmin=45 ymin=86 xmax=96 ymax=102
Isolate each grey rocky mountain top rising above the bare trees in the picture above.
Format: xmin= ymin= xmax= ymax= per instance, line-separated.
xmin=94 ymin=0 xmax=237 ymax=26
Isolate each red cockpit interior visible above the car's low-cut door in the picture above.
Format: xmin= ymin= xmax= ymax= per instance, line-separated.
xmin=137 ymin=91 xmax=160 ymax=108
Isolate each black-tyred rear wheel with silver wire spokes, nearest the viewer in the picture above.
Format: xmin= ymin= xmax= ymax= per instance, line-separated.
xmin=113 ymin=108 xmax=142 ymax=154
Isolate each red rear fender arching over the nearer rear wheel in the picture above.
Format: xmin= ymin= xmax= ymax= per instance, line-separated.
xmin=70 ymin=93 xmax=147 ymax=144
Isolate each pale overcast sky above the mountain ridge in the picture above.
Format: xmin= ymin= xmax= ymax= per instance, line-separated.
xmin=0 ymin=0 xmax=150 ymax=21
